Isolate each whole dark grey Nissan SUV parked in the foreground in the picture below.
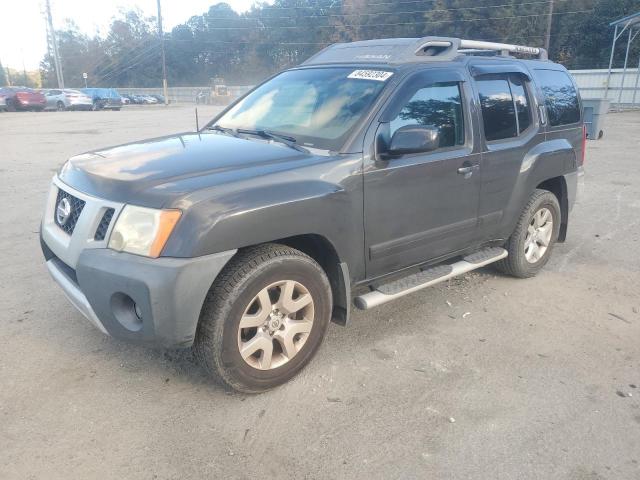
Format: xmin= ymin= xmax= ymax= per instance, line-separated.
xmin=41 ymin=37 xmax=585 ymax=392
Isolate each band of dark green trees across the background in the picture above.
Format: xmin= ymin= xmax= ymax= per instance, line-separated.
xmin=41 ymin=0 xmax=640 ymax=87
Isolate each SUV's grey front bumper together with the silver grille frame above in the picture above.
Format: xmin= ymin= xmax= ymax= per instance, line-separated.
xmin=40 ymin=177 xmax=236 ymax=347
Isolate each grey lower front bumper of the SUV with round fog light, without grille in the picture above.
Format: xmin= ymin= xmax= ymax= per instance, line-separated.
xmin=41 ymin=235 xmax=235 ymax=347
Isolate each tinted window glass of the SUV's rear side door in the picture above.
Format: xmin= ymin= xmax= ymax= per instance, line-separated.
xmin=476 ymin=75 xmax=531 ymax=141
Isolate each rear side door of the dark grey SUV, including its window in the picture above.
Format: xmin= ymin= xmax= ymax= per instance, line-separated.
xmin=471 ymin=65 xmax=544 ymax=241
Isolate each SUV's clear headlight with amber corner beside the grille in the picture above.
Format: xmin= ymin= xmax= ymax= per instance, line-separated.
xmin=109 ymin=205 xmax=182 ymax=258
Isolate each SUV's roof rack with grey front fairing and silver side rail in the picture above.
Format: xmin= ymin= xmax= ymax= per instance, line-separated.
xmin=304 ymin=37 xmax=548 ymax=65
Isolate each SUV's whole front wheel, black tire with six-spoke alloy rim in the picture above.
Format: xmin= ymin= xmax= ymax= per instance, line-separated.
xmin=194 ymin=244 xmax=332 ymax=393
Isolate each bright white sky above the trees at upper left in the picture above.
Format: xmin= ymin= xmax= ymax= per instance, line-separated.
xmin=0 ymin=0 xmax=254 ymax=70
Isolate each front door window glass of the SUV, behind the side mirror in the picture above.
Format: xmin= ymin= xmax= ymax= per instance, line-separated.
xmin=390 ymin=82 xmax=464 ymax=148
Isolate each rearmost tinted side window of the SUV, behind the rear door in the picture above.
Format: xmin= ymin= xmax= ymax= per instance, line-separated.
xmin=535 ymin=70 xmax=580 ymax=127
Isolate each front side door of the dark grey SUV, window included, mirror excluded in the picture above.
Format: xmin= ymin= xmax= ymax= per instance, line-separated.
xmin=364 ymin=68 xmax=480 ymax=278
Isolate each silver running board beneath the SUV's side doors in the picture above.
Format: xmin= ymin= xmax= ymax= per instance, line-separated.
xmin=353 ymin=247 xmax=507 ymax=310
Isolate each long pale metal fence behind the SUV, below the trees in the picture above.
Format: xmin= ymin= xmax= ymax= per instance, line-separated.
xmin=118 ymin=68 xmax=640 ymax=108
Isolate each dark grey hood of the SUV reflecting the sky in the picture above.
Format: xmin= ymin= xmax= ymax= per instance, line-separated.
xmin=59 ymin=132 xmax=323 ymax=208
